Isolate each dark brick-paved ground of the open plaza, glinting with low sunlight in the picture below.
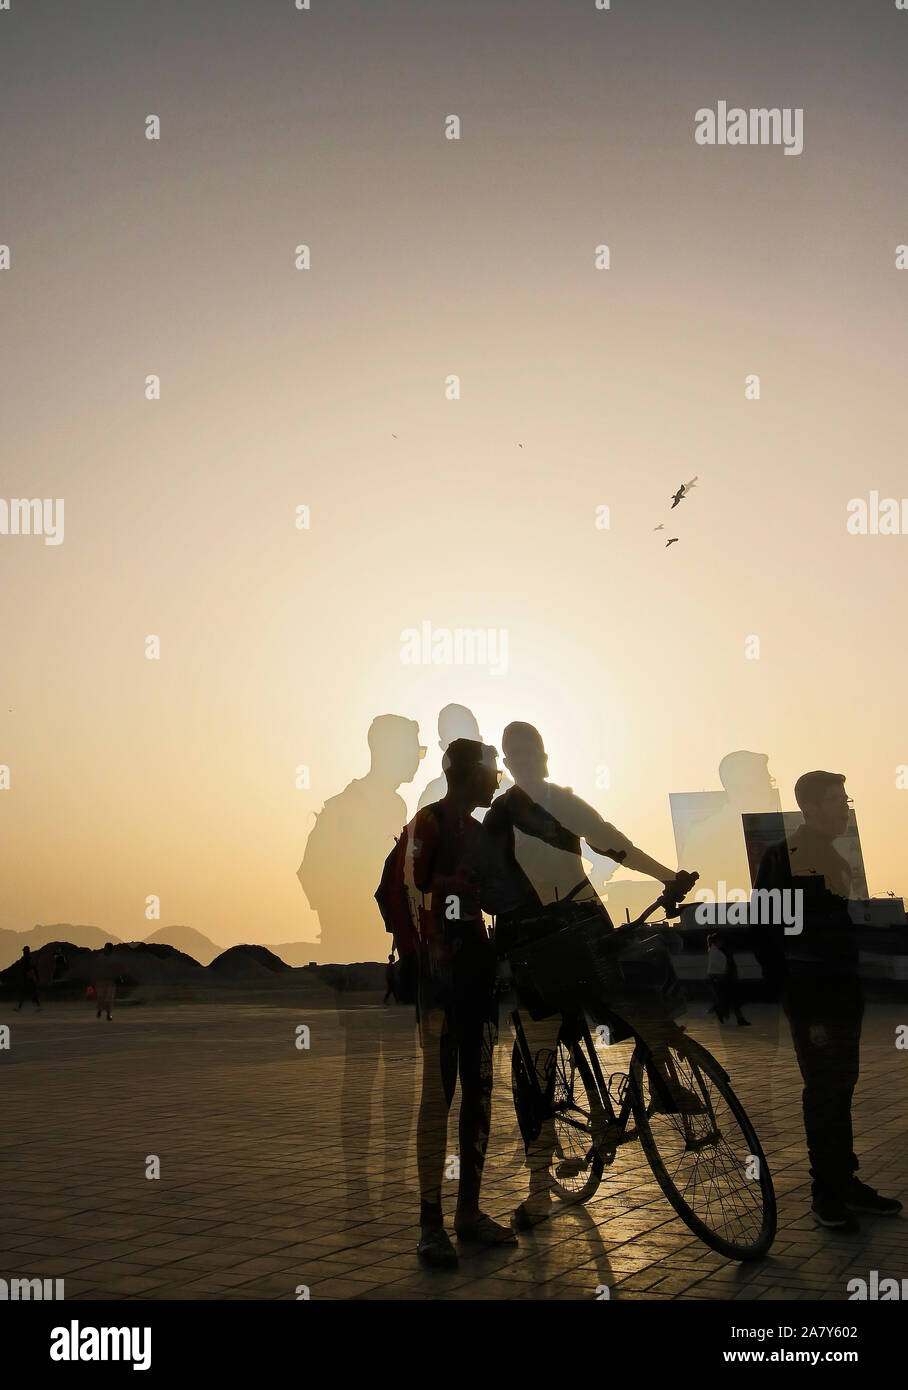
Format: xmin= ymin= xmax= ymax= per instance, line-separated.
xmin=0 ymin=1004 xmax=908 ymax=1300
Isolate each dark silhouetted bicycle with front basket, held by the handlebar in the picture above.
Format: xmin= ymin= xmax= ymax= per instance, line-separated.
xmin=508 ymin=884 xmax=776 ymax=1261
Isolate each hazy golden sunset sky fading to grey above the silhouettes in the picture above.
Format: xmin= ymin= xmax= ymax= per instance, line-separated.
xmin=0 ymin=0 xmax=908 ymax=965
